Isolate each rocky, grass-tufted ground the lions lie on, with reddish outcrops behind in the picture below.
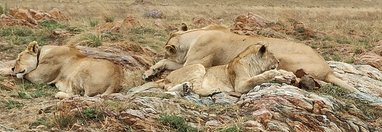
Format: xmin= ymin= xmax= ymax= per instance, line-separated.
xmin=0 ymin=1 xmax=382 ymax=132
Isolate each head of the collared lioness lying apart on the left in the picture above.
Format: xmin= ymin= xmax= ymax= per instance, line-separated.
xmin=12 ymin=41 xmax=39 ymax=78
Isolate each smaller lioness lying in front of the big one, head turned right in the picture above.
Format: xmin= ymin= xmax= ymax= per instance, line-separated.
xmin=165 ymin=44 xmax=286 ymax=96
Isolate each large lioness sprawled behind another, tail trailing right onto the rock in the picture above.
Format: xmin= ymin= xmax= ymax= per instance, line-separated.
xmin=143 ymin=25 xmax=357 ymax=91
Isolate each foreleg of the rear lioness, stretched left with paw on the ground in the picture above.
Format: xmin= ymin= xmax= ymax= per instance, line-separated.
xmin=143 ymin=59 xmax=183 ymax=81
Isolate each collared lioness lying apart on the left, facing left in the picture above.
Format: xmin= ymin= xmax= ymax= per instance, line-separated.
xmin=12 ymin=41 xmax=122 ymax=99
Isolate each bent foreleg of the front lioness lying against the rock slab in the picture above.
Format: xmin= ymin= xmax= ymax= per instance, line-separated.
xmin=235 ymin=70 xmax=280 ymax=93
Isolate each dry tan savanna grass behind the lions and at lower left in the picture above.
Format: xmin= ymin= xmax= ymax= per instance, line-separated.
xmin=0 ymin=0 xmax=382 ymax=129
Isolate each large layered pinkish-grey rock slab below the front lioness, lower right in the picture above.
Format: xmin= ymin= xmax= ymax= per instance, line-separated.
xmin=237 ymin=80 xmax=376 ymax=131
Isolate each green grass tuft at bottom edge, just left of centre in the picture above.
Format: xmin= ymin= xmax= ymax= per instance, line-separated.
xmin=159 ymin=114 xmax=197 ymax=132
